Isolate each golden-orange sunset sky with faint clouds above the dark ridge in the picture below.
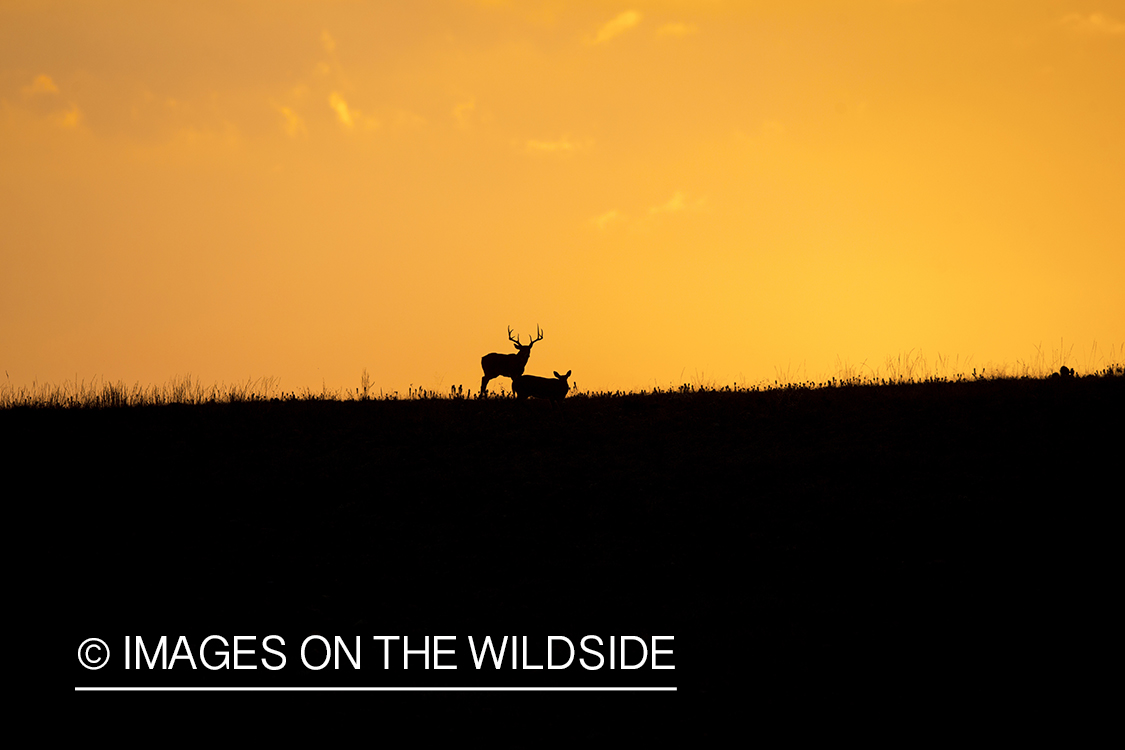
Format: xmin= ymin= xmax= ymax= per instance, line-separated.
xmin=0 ymin=0 xmax=1125 ymax=391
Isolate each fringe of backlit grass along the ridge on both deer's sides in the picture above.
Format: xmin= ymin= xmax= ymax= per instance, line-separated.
xmin=0 ymin=342 xmax=1125 ymax=409
